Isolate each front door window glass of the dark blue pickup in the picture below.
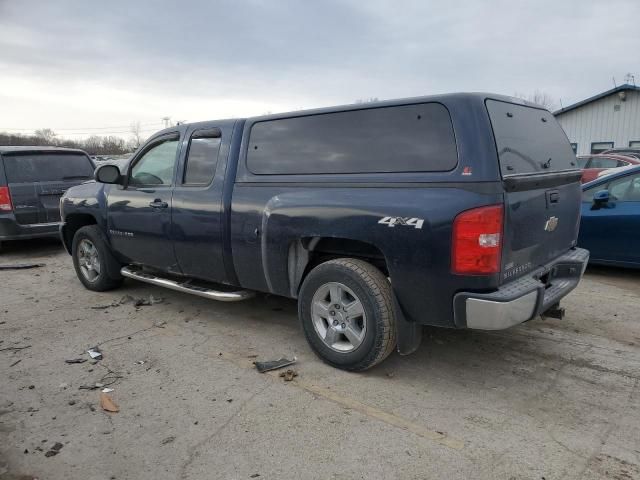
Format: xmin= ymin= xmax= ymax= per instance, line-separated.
xmin=129 ymin=140 xmax=178 ymax=186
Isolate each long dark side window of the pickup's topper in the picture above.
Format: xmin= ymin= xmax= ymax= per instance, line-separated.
xmin=247 ymin=102 xmax=458 ymax=175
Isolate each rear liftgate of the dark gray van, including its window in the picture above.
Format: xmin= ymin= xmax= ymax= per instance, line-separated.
xmin=3 ymin=152 xmax=93 ymax=225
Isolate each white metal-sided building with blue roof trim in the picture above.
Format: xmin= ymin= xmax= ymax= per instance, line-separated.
xmin=554 ymin=84 xmax=640 ymax=155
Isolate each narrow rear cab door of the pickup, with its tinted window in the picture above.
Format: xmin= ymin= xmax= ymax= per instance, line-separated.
xmin=171 ymin=122 xmax=232 ymax=283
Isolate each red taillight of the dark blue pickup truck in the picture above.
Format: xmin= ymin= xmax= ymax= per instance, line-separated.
xmin=451 ymin=205 xmax=504 ymax=275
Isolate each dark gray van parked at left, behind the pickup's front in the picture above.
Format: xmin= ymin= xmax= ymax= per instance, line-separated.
xmin=0 ymin=146 xmax=94 ymax=248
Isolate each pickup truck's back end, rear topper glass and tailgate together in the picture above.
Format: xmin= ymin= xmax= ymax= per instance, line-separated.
xmin=486 ymin=99 xmax=582 ymax=283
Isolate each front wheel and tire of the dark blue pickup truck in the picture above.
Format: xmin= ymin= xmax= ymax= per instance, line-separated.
xmin=71 ymin=225 xmax=123 ymax=292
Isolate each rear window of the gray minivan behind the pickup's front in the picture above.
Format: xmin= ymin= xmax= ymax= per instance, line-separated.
xmin=3 ymin=152 xmax=94 ymax=183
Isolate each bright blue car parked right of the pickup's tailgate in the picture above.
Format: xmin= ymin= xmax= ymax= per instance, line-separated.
xmin=578 ymin=165 xmax=640 ymax=268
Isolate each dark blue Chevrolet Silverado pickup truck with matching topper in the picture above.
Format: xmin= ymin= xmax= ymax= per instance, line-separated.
xmin=61 ymin=94 xmax=589 ymax=370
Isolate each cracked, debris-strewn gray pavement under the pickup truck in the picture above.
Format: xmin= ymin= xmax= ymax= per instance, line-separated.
xmin=0 ymin=240 xmax=640 ymax=480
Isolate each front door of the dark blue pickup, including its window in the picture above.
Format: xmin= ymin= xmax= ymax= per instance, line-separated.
xmin=107 ymin=132 xmax=180 ymax=273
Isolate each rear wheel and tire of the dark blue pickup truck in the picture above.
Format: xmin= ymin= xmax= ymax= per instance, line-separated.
xmin=298 ymin=258 xmax=396 ymax=371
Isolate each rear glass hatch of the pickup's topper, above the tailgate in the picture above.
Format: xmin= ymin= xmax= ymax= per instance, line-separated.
xmin=485 ymin=99 xmax=578 ymax=178
